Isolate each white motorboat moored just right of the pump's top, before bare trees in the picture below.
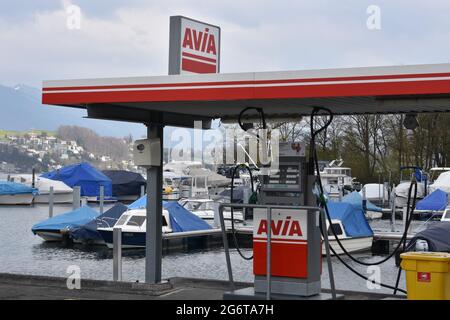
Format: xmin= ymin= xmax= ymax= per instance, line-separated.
xmin=320 ymin=159 xmax=355 ymax=199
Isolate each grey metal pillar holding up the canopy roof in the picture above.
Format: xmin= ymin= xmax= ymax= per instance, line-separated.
xmin=145 ymin=125 xmax=164 ymax=283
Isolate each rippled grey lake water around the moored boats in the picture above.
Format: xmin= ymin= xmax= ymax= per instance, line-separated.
xmin=0 ymin=205 xmax=426 ymax=292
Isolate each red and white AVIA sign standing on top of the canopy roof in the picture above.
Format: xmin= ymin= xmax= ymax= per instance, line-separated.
xmin=169 ymin=16 xmax=220 ymax=74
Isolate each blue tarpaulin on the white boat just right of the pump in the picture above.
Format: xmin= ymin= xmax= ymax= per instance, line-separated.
xmin=327 ymin=201 xmax=373 ymax=238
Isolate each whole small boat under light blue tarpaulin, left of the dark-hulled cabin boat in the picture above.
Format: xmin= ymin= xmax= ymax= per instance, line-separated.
xmin=31 ymin=206 xmax=99 ymax=241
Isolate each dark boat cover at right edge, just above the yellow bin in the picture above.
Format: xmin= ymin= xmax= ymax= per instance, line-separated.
xmin=406 ymin=221 xmax=450 ymax=252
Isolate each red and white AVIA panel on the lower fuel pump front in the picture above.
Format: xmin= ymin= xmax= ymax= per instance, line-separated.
xmin=253 ymin=209 xmax=308 ymax=278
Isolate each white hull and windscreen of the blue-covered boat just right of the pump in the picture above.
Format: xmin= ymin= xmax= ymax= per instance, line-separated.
xmin=322 ymin=219 xmax=373 ymax=255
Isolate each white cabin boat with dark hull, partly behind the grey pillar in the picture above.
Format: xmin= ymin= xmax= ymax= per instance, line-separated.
xmin=97 ymin=209 xmax=172 ymax=248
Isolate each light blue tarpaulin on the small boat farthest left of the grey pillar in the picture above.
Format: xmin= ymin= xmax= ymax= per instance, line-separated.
xmin=31 ymin=206 xmax=98 ymax=233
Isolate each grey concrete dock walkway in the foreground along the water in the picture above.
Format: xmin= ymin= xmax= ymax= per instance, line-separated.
xmin=0 ymin=273 xmax=405 ymax=300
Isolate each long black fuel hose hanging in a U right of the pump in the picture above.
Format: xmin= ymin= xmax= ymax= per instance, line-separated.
xmin=309 ymin=107 xmax=417 ymax=292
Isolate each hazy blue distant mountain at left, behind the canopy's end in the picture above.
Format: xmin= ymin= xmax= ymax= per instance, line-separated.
xmin=0 ymin=84 xmax=146 ymax=139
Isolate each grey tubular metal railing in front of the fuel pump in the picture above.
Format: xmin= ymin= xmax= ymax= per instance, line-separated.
xmin=219 ymin=203 xmax=326 ymax=300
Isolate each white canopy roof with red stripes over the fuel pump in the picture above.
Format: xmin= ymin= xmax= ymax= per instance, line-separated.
xmin=42 ymin=64 xmax=450 ymax=127
